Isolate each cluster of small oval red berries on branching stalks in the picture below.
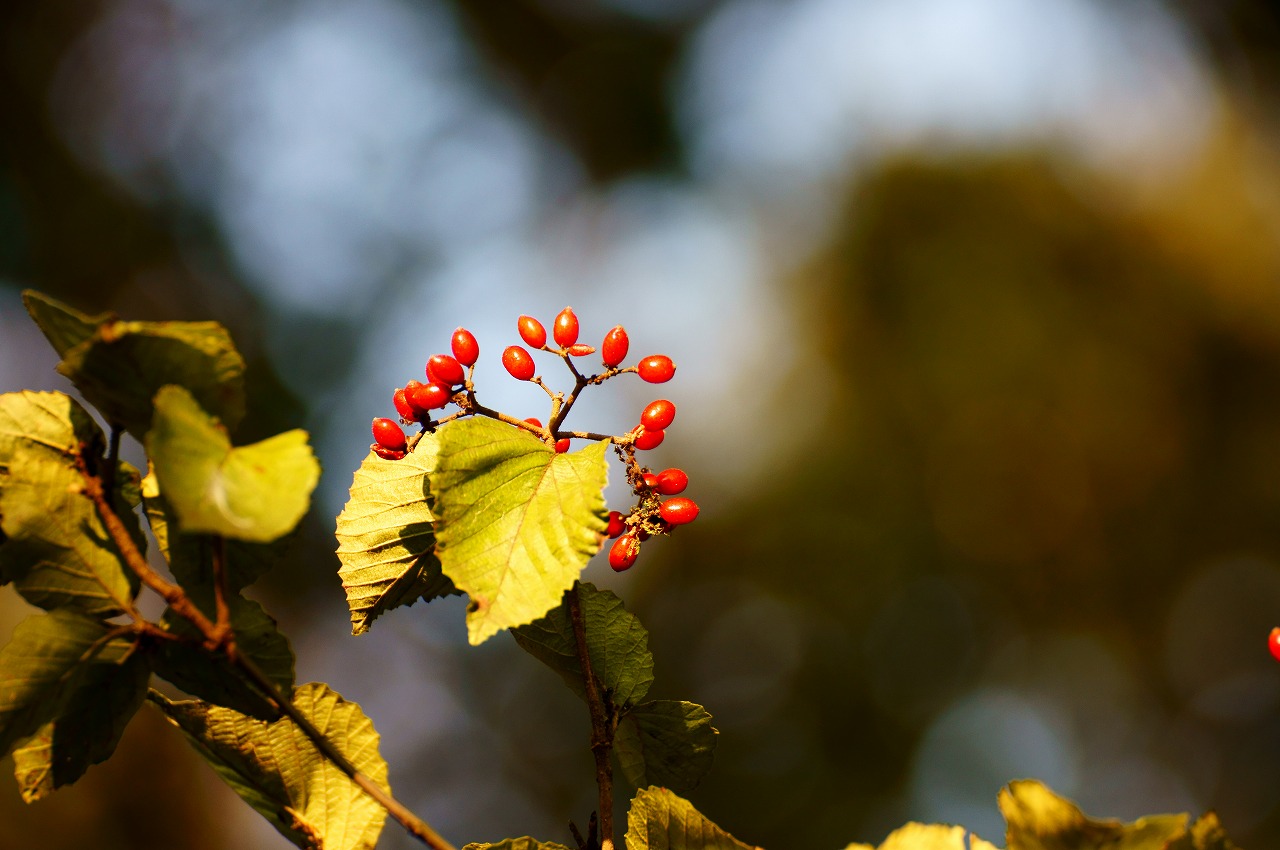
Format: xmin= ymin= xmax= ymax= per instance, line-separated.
xmin=370 ymin=307 xmax=698 ymax=572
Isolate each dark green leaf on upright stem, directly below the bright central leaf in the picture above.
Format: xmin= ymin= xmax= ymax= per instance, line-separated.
xmin=511 ymin=582 xmax=653 ymax=709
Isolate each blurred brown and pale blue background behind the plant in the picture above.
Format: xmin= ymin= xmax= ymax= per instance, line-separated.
xmin=0 ymin=0 xmax=1280 ymax=850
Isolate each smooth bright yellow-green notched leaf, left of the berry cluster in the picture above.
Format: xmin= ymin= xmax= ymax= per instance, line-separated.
xmin=146 ymin=387 xmax=320 ymax=543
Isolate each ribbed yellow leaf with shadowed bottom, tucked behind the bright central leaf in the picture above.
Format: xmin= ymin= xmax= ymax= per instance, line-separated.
xmin=338 ymin=445 xmax=458 ymax=635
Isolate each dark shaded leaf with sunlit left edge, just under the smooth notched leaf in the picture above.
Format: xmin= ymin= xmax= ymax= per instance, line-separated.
xmin=142 ymin=472 xmax=297 ymax=591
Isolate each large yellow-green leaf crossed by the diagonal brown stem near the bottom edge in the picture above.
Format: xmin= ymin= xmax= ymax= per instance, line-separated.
xmin=151 ymin=682 xmax=389 ymax=850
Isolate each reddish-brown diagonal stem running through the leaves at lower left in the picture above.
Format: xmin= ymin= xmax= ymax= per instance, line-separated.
xmin=77 ymin=454 xmax=454 ymax=850
